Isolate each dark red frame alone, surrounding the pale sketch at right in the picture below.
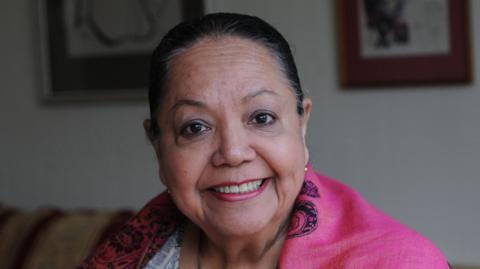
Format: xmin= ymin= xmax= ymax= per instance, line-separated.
xmin=337 ymin=0 xmax=472 ymax=87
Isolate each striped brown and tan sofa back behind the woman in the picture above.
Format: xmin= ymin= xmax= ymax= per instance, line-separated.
xmin=0 ymin=205 xmax=134 ymax=269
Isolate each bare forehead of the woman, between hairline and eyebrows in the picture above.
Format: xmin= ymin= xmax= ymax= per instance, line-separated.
xmin=167 ymin=37 xmax=289 ymax=101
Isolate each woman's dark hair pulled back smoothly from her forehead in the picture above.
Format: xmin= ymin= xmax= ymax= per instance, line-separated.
xmin=148 ymin=13 xmax=304 ymax=138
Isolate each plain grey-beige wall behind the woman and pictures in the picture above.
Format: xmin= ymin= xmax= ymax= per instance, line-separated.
xmin=0 ymin=0 xmax=480 ymax=264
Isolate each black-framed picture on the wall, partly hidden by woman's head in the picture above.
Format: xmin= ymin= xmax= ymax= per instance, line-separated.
xmin=38 ymin=0 xmax=204 ymax=100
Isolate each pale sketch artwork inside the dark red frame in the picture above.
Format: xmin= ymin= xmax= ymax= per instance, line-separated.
xmin=357 ymin=0 xmax=450 ymax=58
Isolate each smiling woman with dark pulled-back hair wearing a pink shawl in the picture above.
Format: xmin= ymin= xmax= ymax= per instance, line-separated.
xmin=79 ymin=14 xmax=448 ymax=268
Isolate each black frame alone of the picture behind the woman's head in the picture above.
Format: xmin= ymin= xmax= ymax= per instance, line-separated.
xmin=39 ymin=0 xmax=204 ymax=100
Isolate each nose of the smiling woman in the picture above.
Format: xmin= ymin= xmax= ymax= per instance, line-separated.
xmin=212 ymin=125 xmax=256 ymax=167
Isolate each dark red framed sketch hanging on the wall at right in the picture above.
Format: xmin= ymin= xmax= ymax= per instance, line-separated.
xmin=337 ymin=0 xmax=472 ymax=87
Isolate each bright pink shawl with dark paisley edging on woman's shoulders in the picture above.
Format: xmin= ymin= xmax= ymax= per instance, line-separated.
xmin=80 ymin=165 xmax=449 ymax=269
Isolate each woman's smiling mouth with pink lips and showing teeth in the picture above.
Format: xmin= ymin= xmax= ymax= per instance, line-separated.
xmin=210 ymin=177 xmax=272 ymax=202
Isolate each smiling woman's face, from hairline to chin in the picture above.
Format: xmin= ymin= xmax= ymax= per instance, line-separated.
xmin=154 ymin=37 xmax=311 ymax=239
